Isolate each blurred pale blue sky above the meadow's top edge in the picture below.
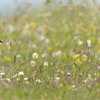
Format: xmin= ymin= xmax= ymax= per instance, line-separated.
xmin=0 ymin=0 xmax=100 ymax=15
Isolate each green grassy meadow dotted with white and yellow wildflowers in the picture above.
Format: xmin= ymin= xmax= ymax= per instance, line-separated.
xmin=0 ymin=4 xmax=100 ymax=100
